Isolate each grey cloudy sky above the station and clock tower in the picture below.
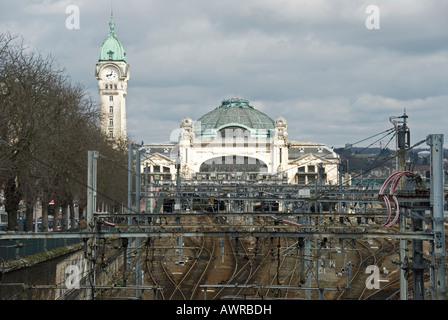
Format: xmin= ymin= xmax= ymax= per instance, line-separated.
xmin=0 ymin=0 xmax=448 ymax=148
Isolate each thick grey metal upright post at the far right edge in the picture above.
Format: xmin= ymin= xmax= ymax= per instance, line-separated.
xmin=426 ymin=134 xmax=446 ymax=300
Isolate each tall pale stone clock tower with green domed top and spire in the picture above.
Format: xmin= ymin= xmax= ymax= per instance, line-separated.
xmin=95 ymin=15 xmax=130 ymax=141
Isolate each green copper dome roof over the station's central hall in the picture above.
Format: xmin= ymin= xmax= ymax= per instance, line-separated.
xmin=198 ymin=98 xmax=274 ymax=136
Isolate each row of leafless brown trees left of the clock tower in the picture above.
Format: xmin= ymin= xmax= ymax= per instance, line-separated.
xmin=0 ymin=34 xmax=127 ymax=231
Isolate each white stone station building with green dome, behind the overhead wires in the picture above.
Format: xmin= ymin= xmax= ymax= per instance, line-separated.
xmin=142 ymin=98 xmax=339 ymax=186
